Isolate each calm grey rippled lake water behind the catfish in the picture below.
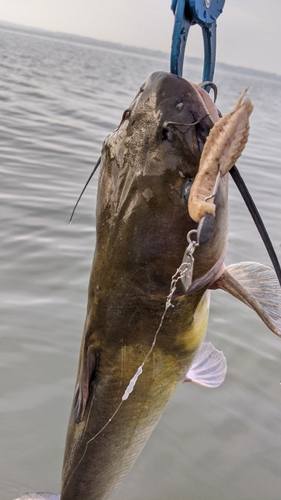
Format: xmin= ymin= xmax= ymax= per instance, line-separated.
xmin=0 ymin=28 xmax=281 ymax=500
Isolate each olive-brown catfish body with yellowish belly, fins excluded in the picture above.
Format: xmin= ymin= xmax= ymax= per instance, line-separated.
xmin=61 ymin=72 xmax=228 ymax=500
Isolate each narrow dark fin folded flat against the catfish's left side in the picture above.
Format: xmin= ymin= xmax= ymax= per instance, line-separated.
xmin=73 ymin=346 xmax=98 ymax=423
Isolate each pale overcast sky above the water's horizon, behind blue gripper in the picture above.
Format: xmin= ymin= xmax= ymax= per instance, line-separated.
xmin=0 ymin=0 xmax=281 ymax=74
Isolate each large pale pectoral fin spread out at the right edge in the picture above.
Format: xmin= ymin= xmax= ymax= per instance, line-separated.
xmin=214 ymin=262 xmax=281 ymax=336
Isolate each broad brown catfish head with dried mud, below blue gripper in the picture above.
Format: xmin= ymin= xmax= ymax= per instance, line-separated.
xmin=96 ymin=72 xmax=228 ymax=290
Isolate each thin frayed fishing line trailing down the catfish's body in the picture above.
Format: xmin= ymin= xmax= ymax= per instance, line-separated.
xmin=67 ymin=263 xmax=189 ymax=484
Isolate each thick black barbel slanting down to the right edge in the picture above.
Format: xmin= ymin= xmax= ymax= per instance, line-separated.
xmin=230 ymin=165 xmax=281 ymax=286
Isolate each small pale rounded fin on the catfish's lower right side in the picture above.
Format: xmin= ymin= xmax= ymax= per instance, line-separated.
xmin=184 ymin=342 xmax=227 ymax=387
